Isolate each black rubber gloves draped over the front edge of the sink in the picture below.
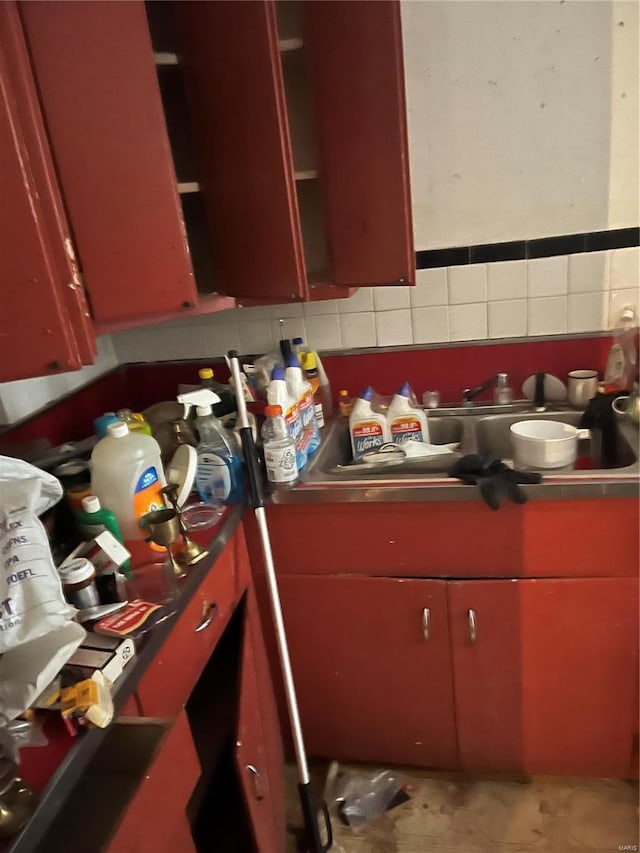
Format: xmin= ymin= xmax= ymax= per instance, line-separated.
xmin=449 ymin=453 xmax=542 ymax=510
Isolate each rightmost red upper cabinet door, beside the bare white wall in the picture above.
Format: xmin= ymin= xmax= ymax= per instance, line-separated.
xmin=304 ymin=0 xmax=415 ymax=286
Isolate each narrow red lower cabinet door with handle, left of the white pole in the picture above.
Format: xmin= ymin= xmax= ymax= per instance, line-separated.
xmin=236 ymin=608 xmax=283 ymax=853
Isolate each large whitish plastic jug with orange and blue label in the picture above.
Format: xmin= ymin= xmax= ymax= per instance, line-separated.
xmin=91 ymin=421 xmax=166 ymax=543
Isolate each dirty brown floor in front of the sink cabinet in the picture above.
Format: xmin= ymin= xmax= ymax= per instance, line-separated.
xmin=287 ymin=764 xmax=640 ymax=853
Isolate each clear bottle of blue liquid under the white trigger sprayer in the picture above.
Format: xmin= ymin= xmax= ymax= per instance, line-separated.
xmin=196 ymin=402 xmax=242 ymax=504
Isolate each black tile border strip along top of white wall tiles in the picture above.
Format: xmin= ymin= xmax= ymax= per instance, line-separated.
xmin=416 ymin=228 xmax=640 ymax=270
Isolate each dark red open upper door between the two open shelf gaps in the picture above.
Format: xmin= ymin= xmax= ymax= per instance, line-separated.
xmin=175 ymin=0 xmax=307 ymax=302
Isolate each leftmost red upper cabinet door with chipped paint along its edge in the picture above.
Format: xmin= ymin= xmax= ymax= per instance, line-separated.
xmin=0 ymin=3 xmax=95 ymax=382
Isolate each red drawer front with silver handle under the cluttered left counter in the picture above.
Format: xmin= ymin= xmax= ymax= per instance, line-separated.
xmin=138 ymin=542 xmax=237 ymax=717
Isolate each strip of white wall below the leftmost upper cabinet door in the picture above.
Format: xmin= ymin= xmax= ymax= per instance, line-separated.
xmin=0 ymin=335 xmax=118 ymax=424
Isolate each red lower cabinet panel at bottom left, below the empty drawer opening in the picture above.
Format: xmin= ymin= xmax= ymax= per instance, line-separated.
xmin=106 ymin=711 xmax=200 ymax=853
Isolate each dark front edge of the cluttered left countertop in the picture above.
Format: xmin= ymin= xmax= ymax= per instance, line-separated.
xmin=5 ymin=505 xmax=244 ymax=853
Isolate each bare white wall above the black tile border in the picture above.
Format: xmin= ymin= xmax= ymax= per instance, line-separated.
xmin=402 ymin=0 xmax=639 ymax=249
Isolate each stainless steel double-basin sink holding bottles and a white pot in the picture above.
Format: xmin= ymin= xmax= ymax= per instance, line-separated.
xmin=301 ymin=401 xmax=640 ymax=484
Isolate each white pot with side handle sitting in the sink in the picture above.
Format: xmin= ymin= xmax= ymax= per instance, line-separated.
xmin=511 ymin=420 xmax=589 ymax=469
